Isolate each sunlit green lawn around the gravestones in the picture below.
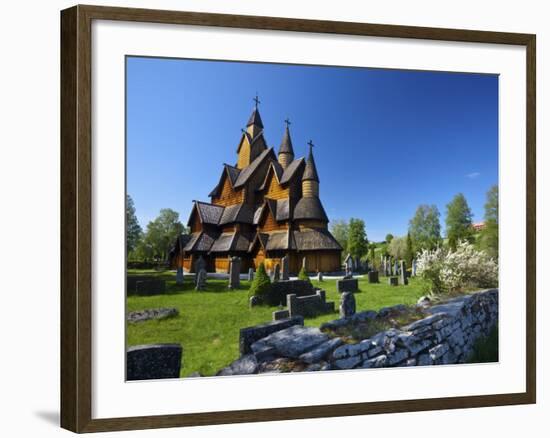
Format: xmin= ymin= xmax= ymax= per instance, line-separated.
xmin=127 ymin=270 xmax=430 ymax=377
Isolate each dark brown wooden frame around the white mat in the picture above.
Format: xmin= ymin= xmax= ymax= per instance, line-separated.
xmin=61 ymin=6 xmax=536 ymax=432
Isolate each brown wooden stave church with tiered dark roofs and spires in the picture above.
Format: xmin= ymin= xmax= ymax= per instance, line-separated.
xmin=172 ymin=98 xmax=342 ymax=273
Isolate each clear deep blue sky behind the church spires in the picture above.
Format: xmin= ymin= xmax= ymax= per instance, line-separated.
xmin=127 ymin=57 xmax=498 ymax=241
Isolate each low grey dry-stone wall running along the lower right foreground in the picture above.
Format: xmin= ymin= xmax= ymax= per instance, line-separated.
xmin=219 ymin=289 xmax=498 ymax=375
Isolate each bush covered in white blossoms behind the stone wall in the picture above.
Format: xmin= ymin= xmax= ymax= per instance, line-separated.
xmin=417 ymin=242 xmax=498 ymax=293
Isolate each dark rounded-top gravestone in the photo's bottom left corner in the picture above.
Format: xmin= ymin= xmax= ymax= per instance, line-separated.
xmin=126 ymin=344 xmax=182 ymax=380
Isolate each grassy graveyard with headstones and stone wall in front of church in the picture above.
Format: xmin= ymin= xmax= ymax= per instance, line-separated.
xmin=127 ymin=258 xmax=498 ymax=378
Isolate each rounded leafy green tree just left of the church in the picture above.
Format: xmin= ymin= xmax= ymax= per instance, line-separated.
xmin=143 ymin=208 xmax=185 ymax=260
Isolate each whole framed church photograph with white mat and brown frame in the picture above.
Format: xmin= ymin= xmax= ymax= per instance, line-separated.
xmin=61 ymin=6 xmax=536 ymax=432
